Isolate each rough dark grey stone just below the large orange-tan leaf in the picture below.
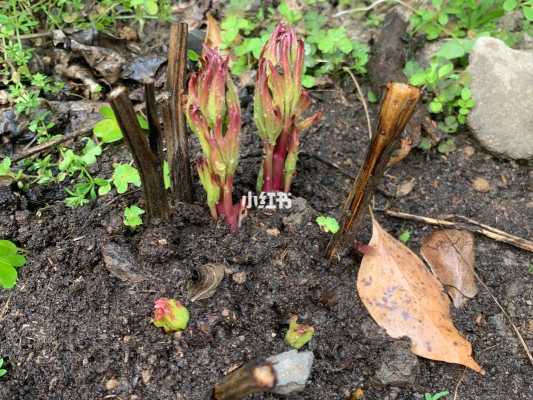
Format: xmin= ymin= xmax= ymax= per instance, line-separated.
xmin=376 ymin=342 xmax=419 ymax=386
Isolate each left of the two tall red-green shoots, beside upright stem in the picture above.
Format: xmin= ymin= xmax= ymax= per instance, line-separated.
xmin=185 ymin=47 xmax=241 ymax=231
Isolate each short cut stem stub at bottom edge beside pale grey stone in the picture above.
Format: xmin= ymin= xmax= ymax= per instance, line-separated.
xmin=213 ymin=361 xmax=276 ymax=400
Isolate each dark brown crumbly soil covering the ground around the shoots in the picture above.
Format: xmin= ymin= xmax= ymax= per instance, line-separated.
xmin=0 ymin=82 xmax=533 ymax=400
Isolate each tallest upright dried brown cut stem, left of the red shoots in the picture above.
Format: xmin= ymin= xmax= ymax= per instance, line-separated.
xmin=164 ymin=23 xmax=192 ymax=203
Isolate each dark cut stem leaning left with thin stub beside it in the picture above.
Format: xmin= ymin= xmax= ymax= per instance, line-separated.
xmin=109 ymin=86 xmax=170 ymax=221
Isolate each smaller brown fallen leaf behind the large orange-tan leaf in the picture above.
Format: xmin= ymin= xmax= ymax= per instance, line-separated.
xmin=420 ymin=229 xmax=478 ymax=308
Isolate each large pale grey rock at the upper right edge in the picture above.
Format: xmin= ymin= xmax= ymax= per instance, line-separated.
xmin=467 ymin=37 xmax=533 ymax=159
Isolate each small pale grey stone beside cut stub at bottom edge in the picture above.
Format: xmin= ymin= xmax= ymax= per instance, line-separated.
xmin=267 ymin=350 xmax=314 ymax=394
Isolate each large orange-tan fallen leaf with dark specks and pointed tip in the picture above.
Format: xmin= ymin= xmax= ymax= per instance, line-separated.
xmin=357 ymin=220 xmax=485 ymax=374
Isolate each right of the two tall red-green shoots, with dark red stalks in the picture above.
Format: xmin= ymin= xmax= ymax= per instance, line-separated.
xmin=254 ymin=24 xmax=320 ymax=192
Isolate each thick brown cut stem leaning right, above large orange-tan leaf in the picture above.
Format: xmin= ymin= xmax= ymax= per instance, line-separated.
xmin=326 ymin=82 xmax=420 ymax=258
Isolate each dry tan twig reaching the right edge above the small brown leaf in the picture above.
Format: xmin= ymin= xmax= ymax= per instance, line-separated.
xmin=374 ymin=210 xmax=533 ymax=252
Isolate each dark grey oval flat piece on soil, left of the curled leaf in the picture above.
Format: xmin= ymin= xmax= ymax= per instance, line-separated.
xmin=102 ymin=242 xmax=146 ymax=283
